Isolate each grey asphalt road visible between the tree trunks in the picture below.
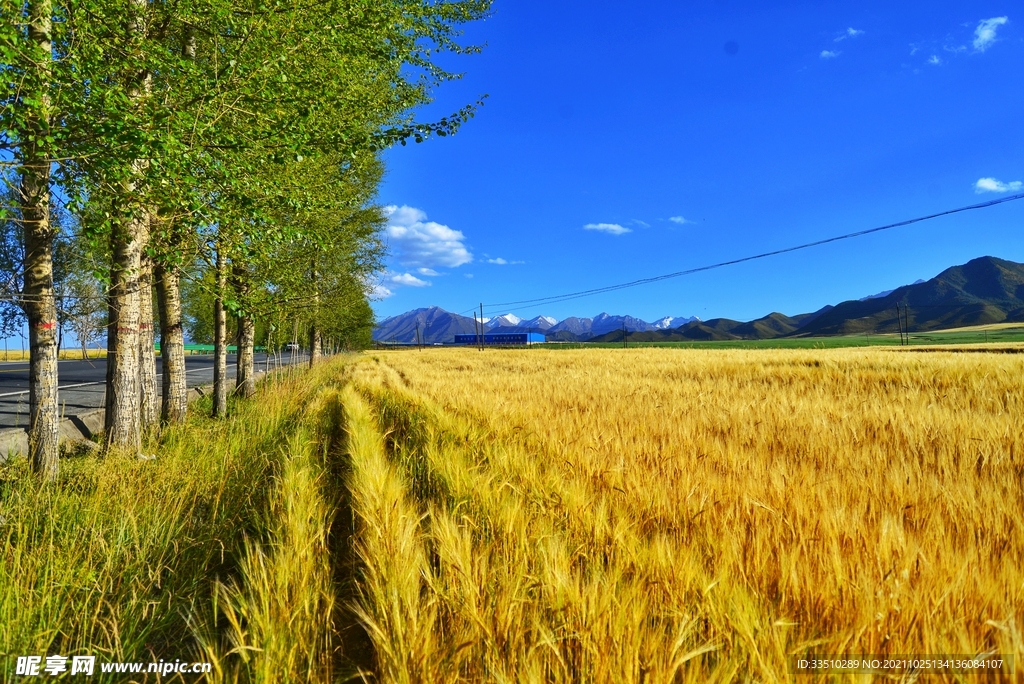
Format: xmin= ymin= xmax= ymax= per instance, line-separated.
xmin=0 ymin=353 xmax=306 ymax=429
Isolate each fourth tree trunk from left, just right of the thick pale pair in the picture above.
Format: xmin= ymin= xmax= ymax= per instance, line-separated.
xmin=156 ymin=262 xmax=188 ymax=425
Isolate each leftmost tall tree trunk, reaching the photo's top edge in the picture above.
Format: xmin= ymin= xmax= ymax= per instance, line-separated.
xmin=18 ymin=0 xmax=60 ymax=480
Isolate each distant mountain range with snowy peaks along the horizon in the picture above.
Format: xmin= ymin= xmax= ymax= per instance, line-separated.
xmin=374 ymin=257 xmax=1024 ymax=344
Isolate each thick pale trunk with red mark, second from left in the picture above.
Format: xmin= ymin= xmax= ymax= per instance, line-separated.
xmin=105 ymin=206 xmax=150 ymax=452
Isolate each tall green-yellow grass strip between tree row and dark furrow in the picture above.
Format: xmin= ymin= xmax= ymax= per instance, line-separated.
xmin=0 ymin=361 xmax=362 ymax=682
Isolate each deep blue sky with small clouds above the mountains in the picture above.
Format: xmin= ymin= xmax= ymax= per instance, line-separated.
xmin=374 ymin=0 xmax=1024 ymax=320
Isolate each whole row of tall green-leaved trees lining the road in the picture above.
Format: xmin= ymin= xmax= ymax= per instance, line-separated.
xmin=0 ymin=0 xmax=489 ymax=478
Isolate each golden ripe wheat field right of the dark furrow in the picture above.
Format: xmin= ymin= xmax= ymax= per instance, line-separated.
xmin=344 ymin=349 xmax=1024 ymax=682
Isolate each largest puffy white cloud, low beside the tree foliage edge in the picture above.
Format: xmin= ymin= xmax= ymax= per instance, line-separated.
xmin=384 ymin=205 xmax=473 ymax=268
